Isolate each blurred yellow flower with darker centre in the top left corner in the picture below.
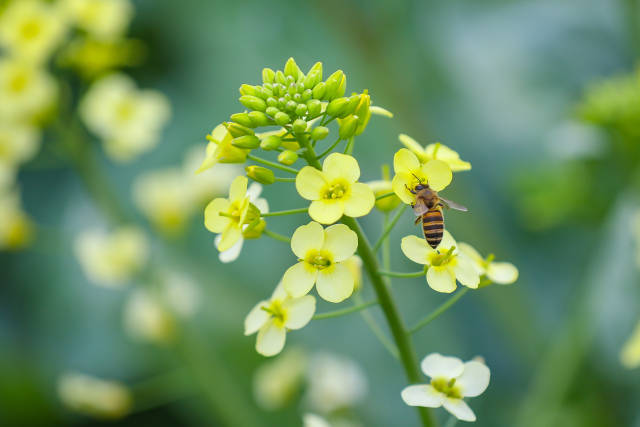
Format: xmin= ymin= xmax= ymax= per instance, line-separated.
xmin=0 ymin=0 xmax=67 ymax=63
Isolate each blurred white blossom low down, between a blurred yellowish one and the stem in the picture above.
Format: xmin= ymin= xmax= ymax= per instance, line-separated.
xmin=306 ymin=353 xmax=367 ymax=414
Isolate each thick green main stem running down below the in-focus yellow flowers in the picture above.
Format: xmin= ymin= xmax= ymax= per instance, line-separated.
xmin=342 ymin=216 xmax=435 ymax=427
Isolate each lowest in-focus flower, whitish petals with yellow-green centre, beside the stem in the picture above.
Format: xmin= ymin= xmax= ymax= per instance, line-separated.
xmin=401 ymin=353 xmax=491 ymax=421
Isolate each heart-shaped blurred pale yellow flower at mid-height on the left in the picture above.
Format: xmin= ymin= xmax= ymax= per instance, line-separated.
xmin=75 ymin=227 xmax=149 ymax=286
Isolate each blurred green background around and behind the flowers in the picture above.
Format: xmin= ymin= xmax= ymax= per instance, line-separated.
xmin=0 ymin=0 xmax=640 ymax=427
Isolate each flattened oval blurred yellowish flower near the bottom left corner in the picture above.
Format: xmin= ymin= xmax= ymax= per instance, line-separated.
xmin=58 ymin=372 xmax=133 ymax=419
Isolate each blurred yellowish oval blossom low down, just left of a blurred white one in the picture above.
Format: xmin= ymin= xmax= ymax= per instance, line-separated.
xmin=253 ymin=348 xmax=307 ymax=411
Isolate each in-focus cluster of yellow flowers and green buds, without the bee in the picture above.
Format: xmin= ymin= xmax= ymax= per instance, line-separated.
xmin=199 ymin=58 xmax=518 ymax=425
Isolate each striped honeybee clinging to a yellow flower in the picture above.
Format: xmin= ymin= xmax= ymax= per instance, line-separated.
xmin=407 ymin=182 xmax=468 ymax=249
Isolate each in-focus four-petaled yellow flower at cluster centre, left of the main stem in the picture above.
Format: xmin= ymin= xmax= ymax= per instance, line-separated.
xmin=282 ymin=222 xmax=358 ymax=303
